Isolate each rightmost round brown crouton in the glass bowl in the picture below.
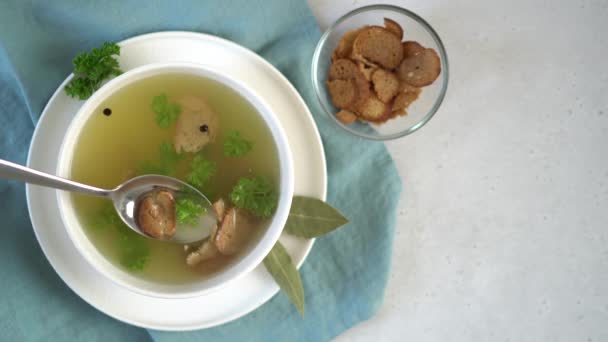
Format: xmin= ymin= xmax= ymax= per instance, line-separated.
xmin=397 ymin=43 xmax=441 ymax=87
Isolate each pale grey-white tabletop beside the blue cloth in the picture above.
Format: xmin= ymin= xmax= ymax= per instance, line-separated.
xmin=309 ymin=0 xmax=608 ymax=342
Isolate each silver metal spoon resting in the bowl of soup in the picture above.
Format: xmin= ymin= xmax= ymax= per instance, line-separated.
xmin=0 ymin=159 xmax=217 ymax=244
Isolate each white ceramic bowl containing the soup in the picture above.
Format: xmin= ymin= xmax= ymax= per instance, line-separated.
xmin=57 ymin=62 xmax=294 ymax=298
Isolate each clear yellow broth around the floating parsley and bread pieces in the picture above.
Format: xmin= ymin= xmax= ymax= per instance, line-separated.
xmin=70 ymin=73 xmax=279 ymax=284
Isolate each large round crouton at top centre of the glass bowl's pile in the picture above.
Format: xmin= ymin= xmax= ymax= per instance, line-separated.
xmin=351 ymin=26 xmax=403 ymax=69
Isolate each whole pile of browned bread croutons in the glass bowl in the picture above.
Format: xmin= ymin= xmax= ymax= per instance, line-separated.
xmin=326 ymin=18 xmax=441 ymax=124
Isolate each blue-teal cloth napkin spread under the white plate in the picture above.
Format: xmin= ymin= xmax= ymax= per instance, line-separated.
xmin=0 ymin=0 xmax=401 ymax=341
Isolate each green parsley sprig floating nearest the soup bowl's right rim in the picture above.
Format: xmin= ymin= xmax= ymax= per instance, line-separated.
xmin=230 ymin=177 xmax=278 ymax=218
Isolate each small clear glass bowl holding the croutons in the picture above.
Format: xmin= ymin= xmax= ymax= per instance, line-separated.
xmin=311 ymin=5 xmax=449 ymax=140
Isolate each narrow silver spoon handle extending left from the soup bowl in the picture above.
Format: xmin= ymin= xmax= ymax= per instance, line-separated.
xmin=0 ymin=159 xmax=111 ymax=197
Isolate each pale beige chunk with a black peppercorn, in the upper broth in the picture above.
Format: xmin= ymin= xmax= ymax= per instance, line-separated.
xmin=173 ymin=96 xmax=219 ymax=153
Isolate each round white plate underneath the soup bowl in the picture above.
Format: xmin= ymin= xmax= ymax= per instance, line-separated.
xmin=26 ymin=32 xmax=327 ymax=330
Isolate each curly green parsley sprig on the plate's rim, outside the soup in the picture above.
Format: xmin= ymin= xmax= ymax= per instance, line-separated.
xmin=65 ymin=42 xmax=122 ymax=100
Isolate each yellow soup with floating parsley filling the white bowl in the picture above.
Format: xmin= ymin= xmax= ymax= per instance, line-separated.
xmin=70 ymin=73 xmax=279 ymax=283
